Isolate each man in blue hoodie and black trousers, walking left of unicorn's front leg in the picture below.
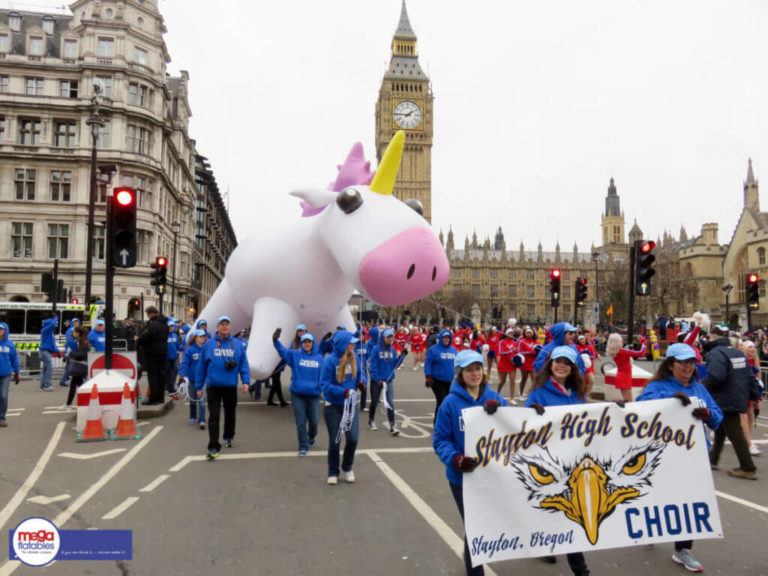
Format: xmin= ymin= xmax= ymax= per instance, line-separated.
xmin=195 ymin=316 xmax=251 ymax=460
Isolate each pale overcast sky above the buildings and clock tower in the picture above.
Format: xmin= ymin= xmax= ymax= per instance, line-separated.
xmin=16 ymin=0 xmax=768 ymax=250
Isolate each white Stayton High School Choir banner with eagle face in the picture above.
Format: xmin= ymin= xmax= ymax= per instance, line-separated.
xmin=463 ymin=399 xmax=723 ymax=566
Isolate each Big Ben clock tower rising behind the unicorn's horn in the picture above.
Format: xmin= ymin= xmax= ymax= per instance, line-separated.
xmin=376 ymin=0 xmax=433 ymax=223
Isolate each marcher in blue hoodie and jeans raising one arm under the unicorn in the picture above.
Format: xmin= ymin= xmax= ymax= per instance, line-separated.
xmin=272 ymin=328 xmax=323 ymax=456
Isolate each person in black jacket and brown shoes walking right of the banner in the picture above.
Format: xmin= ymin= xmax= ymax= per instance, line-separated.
xmin=703 ymin=326 xmax=760 ymax=480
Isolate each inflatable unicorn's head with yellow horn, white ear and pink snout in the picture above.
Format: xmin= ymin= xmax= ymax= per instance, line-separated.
xmin=292 ymin=131 xmax=450 ymax=306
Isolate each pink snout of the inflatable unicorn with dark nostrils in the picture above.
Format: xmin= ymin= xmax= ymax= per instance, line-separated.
xmin=360 ymin=227 xmax=450 ymax=306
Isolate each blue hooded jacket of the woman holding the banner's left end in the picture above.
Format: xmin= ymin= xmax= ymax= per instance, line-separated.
xmin=432 ymin=382 xmax=507 ymax=486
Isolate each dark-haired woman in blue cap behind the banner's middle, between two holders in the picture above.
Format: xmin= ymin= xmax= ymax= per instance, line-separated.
xmin=525 ymin=346 xmax=589 ymax=576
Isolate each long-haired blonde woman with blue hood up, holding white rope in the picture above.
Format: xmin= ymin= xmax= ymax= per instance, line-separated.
xmin=320 ymin=330 xmax=360 ymax=486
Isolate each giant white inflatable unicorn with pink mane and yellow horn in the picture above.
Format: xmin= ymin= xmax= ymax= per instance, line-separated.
xmin=194 ymin=131 xmax=449 ymax=379
